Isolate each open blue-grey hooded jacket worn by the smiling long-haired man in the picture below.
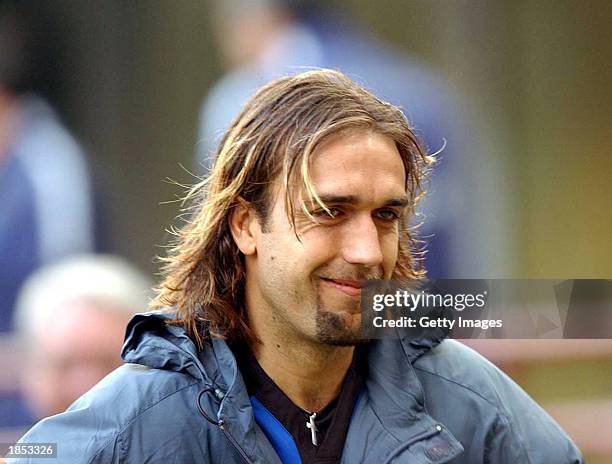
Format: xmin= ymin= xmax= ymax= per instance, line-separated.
xmin=8 ymin=313 xmax=582 ymax=464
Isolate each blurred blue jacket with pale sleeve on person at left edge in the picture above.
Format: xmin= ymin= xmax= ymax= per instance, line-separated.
xmin=0 ymin=96 xmax=97 ymax=333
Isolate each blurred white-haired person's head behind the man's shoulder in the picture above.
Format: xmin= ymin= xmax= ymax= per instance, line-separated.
xmin=11 ymin=255 xmax=151 ymax=426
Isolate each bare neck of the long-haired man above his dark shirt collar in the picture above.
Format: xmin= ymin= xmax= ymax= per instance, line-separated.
xmin=253 ymin=336 xmax=354 ymax=412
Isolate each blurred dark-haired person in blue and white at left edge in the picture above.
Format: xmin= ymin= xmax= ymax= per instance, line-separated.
xmin=0 ymin=1 xmax=101 ymax=334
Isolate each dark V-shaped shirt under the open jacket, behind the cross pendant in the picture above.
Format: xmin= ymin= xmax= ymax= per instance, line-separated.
xmin=234 ymin=346 xmax=367 ymax=464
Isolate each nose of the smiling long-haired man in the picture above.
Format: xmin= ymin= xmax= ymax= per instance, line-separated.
xmin=342 ymin=216 xmax=383 ymax=266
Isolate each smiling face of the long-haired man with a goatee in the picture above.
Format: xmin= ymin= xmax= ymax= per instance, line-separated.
xmin=234 ymin=129 xmax=408 ymax=345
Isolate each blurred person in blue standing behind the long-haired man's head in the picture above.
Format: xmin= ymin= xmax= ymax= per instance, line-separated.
xmin=196 ymin=0 xmax=509 ymax=278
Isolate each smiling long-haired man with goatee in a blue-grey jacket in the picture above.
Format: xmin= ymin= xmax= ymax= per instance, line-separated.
xmin=11 ymin=70 xmax=582 ymax=464
